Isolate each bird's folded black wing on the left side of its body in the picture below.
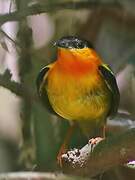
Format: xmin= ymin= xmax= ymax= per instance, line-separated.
xmin=36 ymin=66 xmax=56 ymax=114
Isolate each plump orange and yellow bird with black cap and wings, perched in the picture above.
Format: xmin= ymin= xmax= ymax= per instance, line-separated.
xmin=36 ymin=36 xmax=120 ymax=166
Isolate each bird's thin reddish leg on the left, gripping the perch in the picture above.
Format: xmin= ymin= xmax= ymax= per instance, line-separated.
xmin=57 ymin=124 xmax=75 ymax=167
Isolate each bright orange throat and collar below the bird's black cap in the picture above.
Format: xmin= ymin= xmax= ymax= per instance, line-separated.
xmin=57 ymin=48 xmax=101 ymax=76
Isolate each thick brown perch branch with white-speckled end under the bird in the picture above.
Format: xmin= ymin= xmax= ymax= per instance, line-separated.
xmin=62 ymin=128 xmax=135 ymax=177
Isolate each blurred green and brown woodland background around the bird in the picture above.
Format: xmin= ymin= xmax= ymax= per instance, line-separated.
xmin=0 ymin=0 xmax=135 ymax=180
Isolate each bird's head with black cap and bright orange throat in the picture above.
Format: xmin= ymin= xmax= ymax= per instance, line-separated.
xmin=54 ymin=36 xmax=101 ymax=74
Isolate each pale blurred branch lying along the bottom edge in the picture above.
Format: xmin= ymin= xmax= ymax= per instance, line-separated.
xmin=0 ymin=172 xmax=92 ymax=180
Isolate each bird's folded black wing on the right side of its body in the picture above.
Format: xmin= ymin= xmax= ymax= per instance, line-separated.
xmin=99 ymin=64 xmax=120 ymax=117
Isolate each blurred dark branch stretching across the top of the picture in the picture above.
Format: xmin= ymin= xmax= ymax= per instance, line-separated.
xmin=0 ymin=0 xmax=120 ymax=25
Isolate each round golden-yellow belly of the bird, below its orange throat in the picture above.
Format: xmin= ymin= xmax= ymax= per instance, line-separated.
xmin=47 ymin=67 xmax=111 ymax=122
